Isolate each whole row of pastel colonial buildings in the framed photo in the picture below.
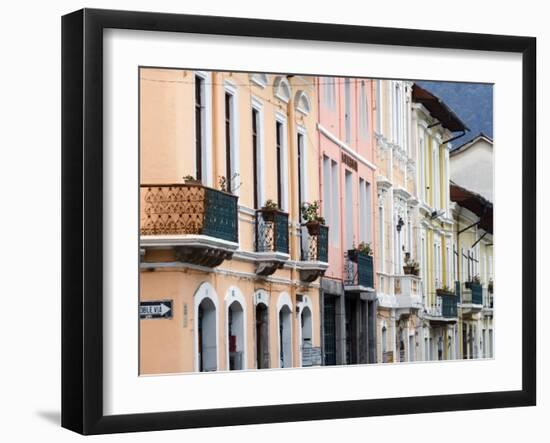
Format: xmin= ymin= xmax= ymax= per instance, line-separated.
xmin=139 ymin=68 xmax=493 ymax=374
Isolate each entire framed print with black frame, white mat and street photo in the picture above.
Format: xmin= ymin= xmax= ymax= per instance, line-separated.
xmin=62 ymin=9 xmax=536 ymax=434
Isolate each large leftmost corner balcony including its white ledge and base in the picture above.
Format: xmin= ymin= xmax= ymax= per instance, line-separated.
xmin=140 ymin=183 xmax=239 ymax=268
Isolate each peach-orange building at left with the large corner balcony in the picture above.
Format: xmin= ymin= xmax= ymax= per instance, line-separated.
xmin=140 ymin=68 xmax=330 ymax=374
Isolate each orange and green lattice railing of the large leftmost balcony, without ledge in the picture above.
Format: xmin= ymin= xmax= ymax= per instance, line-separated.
xmin=140 ymin=184 xmax=238 ymax=243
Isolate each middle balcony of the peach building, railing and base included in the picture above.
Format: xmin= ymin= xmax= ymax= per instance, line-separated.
xmin=255 ymin=209 xmax=289 ymax=276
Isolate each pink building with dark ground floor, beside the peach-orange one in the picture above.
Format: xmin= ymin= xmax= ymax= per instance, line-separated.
xmin=316 ymin=77 xmax=377 ymax=365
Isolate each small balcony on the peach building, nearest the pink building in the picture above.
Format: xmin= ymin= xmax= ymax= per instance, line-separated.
xmin=297 ymin=224 xmax=328 ymax=283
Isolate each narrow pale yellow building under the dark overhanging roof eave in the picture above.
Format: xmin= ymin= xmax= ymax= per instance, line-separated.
xmin=412 ymin=84 xmax=467 ymax=360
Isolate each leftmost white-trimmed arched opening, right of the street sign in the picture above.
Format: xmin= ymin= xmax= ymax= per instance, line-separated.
xmin=194 ymin=282 xmax=218 ymax=372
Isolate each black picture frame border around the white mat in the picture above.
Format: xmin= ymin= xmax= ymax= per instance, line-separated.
xmin=62 ymin=9 xmax=536 ymax=434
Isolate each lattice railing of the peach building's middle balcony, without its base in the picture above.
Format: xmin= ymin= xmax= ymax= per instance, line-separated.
xmin=256 ymin=209 xmax=288 ymax=254
